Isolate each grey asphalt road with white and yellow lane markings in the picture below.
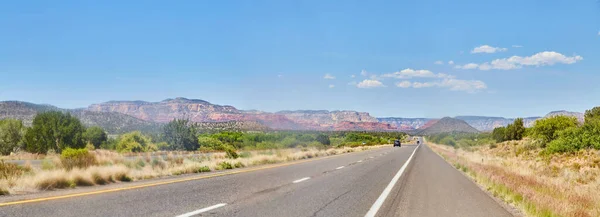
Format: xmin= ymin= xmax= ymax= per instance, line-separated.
xmin=0 ymin=145 xmax=512 ymax=217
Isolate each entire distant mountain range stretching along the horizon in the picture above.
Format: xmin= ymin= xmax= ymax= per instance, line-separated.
xmin=0 ymin=97 xmax=583 ymax=134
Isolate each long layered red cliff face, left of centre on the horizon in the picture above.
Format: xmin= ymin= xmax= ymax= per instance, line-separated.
xmin=88 ymin=98 xmax=386 ymax=130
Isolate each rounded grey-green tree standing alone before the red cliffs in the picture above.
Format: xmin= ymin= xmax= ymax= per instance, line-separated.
xmin=163 ymin=119 xmax=200 ymax=151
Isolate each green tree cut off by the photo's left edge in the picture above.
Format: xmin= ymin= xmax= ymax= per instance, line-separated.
xmin=0 ymin=119 xmax=25 ymax=155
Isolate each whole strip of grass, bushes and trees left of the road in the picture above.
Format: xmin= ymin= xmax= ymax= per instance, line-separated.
xmin=0 ymin=111 xmax=407 ymax=195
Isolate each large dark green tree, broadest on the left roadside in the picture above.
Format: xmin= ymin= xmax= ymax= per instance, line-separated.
xmin=25 ymin=111 xmax=85 ymax=153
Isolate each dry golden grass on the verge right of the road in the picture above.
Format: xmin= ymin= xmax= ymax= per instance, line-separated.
xmin=429 ymin=140 xmax=600 ymax=217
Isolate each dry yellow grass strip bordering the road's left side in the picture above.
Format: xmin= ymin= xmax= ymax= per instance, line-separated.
xmin=0 ymin=146 xmax=381 ymax=194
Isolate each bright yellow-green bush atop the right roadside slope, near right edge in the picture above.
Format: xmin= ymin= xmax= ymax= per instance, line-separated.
xmin=531 ymin=115 xmax=577 ymax=147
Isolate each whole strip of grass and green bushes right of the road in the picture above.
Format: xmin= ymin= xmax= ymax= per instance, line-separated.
xmin=428 ymin=107 xmax=600 ymax=216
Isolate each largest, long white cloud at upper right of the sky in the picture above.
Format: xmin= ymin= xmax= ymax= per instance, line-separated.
xmin=456 ymin=51 xmax=583 ymax=70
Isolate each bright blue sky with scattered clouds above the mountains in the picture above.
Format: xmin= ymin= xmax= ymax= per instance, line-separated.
xmin=0 ymin=0 xmax=600 ymax=117
